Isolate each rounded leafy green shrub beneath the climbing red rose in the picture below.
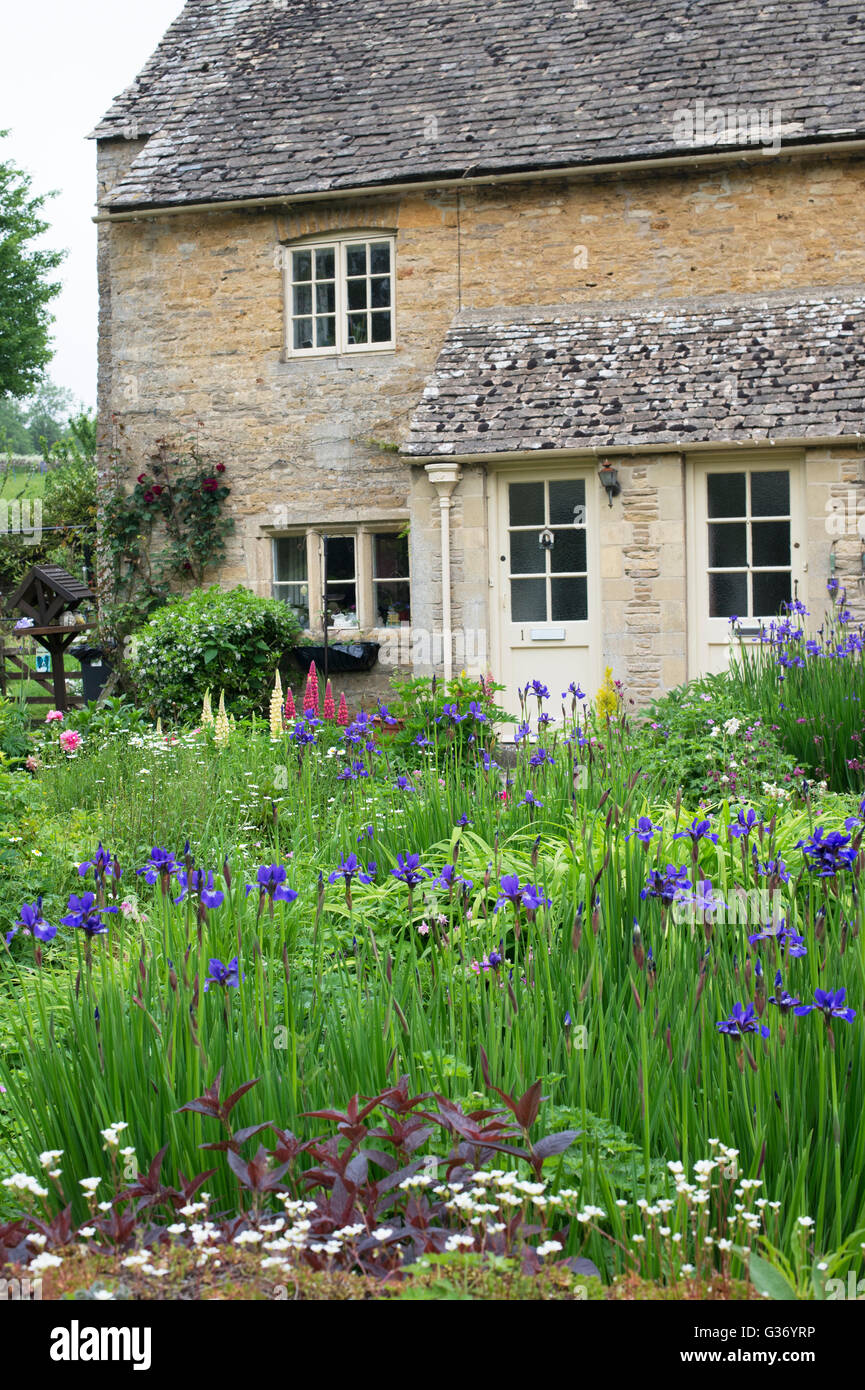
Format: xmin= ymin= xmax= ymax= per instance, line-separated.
xmin=131 ymin=587 xmax=299 ymax=721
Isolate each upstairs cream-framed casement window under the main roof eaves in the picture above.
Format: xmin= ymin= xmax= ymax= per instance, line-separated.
xmin=285 ymin=236 xmax=395 ymax=357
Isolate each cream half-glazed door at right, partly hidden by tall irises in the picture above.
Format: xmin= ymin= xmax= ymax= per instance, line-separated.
xmin=688 ymin=450 xmax=805 ymax=676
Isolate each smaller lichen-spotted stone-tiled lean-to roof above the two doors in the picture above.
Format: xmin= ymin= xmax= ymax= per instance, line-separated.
xmin=403 ymin=288 xmax=865 ymax=457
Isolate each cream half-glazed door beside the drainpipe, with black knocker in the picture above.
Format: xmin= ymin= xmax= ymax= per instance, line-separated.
xmin=490 ymin=468 xmax=599 ymax=716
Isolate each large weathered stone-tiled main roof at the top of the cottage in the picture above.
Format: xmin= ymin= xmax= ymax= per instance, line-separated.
xmin=95 ymin=0 xmax=865 ymax=210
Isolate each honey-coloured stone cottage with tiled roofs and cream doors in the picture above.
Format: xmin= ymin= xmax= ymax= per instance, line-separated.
xmin=95 ymin=0 xmax=865 ymax=706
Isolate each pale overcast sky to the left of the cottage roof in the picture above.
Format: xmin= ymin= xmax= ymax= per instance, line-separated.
xmin=0 ymin=0 xmax=184 ymax=406
